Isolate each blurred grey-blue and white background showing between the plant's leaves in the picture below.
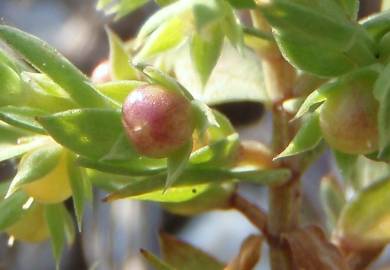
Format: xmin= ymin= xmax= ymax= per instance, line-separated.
xmin=0 ymin=0 xmax=380 ymax=270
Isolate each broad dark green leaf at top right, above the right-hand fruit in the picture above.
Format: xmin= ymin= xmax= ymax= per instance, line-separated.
xmin=260 ymin=0 xmax=376 ymax=77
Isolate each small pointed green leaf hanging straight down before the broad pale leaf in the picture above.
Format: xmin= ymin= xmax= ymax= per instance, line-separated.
xmin=191 ymin=27 xmax=224 ymax=86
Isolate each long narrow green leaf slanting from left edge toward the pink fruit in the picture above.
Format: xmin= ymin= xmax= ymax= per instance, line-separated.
xmin=0 ymin=25 xmax=113 ymax=107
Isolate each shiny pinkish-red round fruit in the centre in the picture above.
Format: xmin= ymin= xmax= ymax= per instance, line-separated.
xmin=122 ymin=85 xmax=194 ymax=158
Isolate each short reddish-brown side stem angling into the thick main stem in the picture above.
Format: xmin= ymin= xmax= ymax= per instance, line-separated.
xmin=230 ymin=193 xmax=268 ymax=235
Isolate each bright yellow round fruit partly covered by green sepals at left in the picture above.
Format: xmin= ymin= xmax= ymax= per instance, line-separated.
xmin=21 ymin=151 xmax=72 ymax=203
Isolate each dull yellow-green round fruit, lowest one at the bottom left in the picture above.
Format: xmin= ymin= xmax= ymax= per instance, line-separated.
xmin=6 ymin=205 xmax=49 ymax=243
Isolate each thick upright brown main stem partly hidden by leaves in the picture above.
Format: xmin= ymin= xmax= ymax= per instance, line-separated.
xmin=251 ymin=10 xmax=301 ymax=270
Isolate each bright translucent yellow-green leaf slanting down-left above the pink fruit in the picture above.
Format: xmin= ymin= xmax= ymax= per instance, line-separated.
xmin=134 ymin=17 xmax=187 ymax=63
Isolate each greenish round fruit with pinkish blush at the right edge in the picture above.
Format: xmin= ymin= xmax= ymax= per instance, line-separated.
xmin=320 ymin=77 xmax=379 ymax=154
